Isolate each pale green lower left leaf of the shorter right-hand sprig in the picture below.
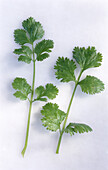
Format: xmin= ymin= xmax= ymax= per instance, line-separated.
xmin=41 ymin=103 xmax=66 ymax=131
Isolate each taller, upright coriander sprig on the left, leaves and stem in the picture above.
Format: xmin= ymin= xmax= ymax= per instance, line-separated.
xmin=12 ymin=17 xmax=58 ymax=156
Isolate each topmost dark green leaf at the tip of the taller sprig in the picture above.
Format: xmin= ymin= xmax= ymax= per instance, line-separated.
xmin=22 ymin=17 xmax=44 ymax=43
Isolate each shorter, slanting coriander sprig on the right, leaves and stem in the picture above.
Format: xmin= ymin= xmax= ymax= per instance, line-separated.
xmin=41 ymin=47 xmax=104 ymax=154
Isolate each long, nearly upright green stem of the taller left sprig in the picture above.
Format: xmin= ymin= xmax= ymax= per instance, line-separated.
xmin=21 ymin=44 xmax=35 ymax=157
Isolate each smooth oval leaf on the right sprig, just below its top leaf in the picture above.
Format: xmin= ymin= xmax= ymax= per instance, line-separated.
xmin=78 ymin=76 xmax=104 ymax=94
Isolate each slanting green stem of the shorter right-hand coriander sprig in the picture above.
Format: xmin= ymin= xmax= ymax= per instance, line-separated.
xmin=56 ymin=70 xmax=83 ymax=154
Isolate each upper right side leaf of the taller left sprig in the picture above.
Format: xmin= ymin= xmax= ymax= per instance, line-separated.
xmin=35 ymin=40 xmax=54 ymax=61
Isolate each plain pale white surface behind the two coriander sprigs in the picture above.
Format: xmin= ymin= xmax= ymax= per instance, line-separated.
xmin=0 ymin=0 xmax=108 ymax=170
